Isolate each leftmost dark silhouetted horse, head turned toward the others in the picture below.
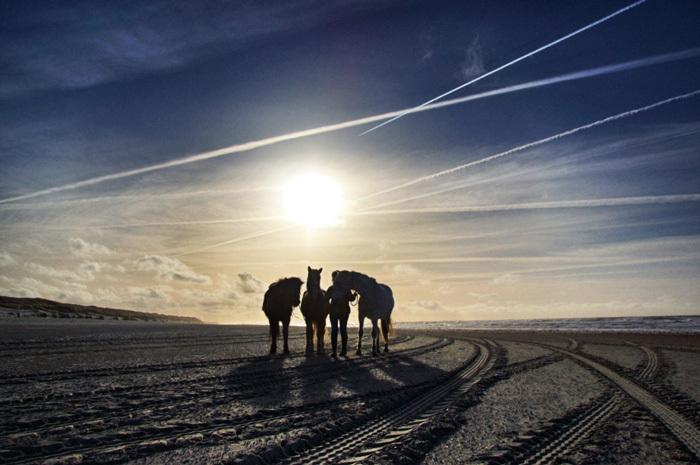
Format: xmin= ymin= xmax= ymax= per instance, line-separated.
xmin=262 ymin=278 xmax=304 ymax=355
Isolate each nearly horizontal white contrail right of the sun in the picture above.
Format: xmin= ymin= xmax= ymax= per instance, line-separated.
xmin=348 ymin=193 xmax=700 ymax=216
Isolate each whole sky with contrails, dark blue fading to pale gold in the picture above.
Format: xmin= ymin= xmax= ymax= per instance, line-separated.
xmin=0 ymin=0 xmax=700 ymax=323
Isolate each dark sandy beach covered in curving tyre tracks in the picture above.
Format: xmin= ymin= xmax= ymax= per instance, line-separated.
xmin=0 ymin=322 xmax=700 ymax=464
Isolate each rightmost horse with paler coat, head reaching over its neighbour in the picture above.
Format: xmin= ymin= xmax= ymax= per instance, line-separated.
xmin=331 ymin=271 xmax=394 ymax=355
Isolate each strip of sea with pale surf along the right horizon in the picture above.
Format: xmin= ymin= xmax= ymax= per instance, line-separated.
xmin=396 ymin=315 xmax=700 ymax=334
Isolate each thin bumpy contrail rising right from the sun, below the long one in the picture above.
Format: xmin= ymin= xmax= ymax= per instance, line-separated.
xmin=357 ymin=89 xmax=700 ymax=200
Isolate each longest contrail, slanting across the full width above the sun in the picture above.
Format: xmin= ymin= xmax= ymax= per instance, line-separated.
xmin=5 ymin=48 xmax=700 ymax=204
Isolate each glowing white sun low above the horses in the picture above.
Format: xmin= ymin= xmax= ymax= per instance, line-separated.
xmin=282 ymin=173 xmax=343 ymax=227
